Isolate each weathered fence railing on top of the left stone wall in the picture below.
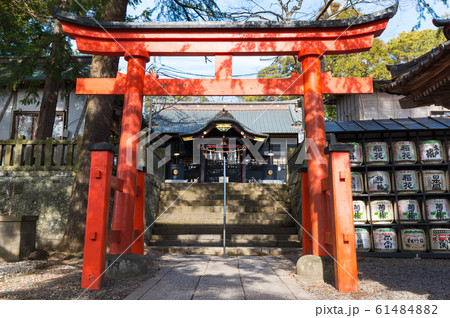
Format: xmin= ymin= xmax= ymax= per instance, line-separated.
xmin=0 ymin=136 xmax=77 ymax=170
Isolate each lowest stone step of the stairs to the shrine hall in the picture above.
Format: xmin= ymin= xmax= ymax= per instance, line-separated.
xmin=146 ymin=246 xmax=301 ymax=256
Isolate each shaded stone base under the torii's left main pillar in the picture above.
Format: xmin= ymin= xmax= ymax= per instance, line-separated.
xmin=105 ymin=254 xmax=148 ymax=279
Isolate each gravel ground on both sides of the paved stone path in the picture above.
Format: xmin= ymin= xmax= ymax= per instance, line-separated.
xmin=0 ymin=250 xmax=450 ymax=300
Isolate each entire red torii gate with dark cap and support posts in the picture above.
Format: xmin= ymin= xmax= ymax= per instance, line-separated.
xmin=54 ymin=5 xmax=397 ymax=292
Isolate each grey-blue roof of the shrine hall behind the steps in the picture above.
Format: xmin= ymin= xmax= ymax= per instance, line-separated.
xmin=152 ymin=100 xmax=302 ymax=134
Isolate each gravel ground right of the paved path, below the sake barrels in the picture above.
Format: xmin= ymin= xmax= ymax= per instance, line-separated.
xmin=280 ymin=256 xmax=450 ymax=300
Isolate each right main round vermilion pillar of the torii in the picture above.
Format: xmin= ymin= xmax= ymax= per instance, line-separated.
xmin=299 ymin=48 xmax=331 ymax=256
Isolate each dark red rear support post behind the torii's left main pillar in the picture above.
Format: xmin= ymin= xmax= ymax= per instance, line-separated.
xmin=131 ymin=171 xmax=146 ymax=255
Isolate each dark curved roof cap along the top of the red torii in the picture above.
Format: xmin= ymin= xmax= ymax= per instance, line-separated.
xmin=53 ymin=2 xmax=398 ymax=29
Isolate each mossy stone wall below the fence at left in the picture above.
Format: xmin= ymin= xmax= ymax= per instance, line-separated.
xmin=0 ymin=170 xmax=75 ymax=248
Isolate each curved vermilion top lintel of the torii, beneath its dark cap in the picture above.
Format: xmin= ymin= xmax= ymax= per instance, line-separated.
xmin=62 ymin=19 xmax=389 ymax=56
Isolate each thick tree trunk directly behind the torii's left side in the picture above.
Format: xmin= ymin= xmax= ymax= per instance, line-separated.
xmin=59 ymin=0 xmax=128 ymax=252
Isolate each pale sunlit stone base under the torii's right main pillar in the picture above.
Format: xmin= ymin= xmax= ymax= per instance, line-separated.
xmin=296 ymin=255 xmax=334 ymax=284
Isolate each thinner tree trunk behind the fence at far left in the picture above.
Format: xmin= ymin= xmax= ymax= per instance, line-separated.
xmin=36 ymin=20 xmax=64 ymax=140
